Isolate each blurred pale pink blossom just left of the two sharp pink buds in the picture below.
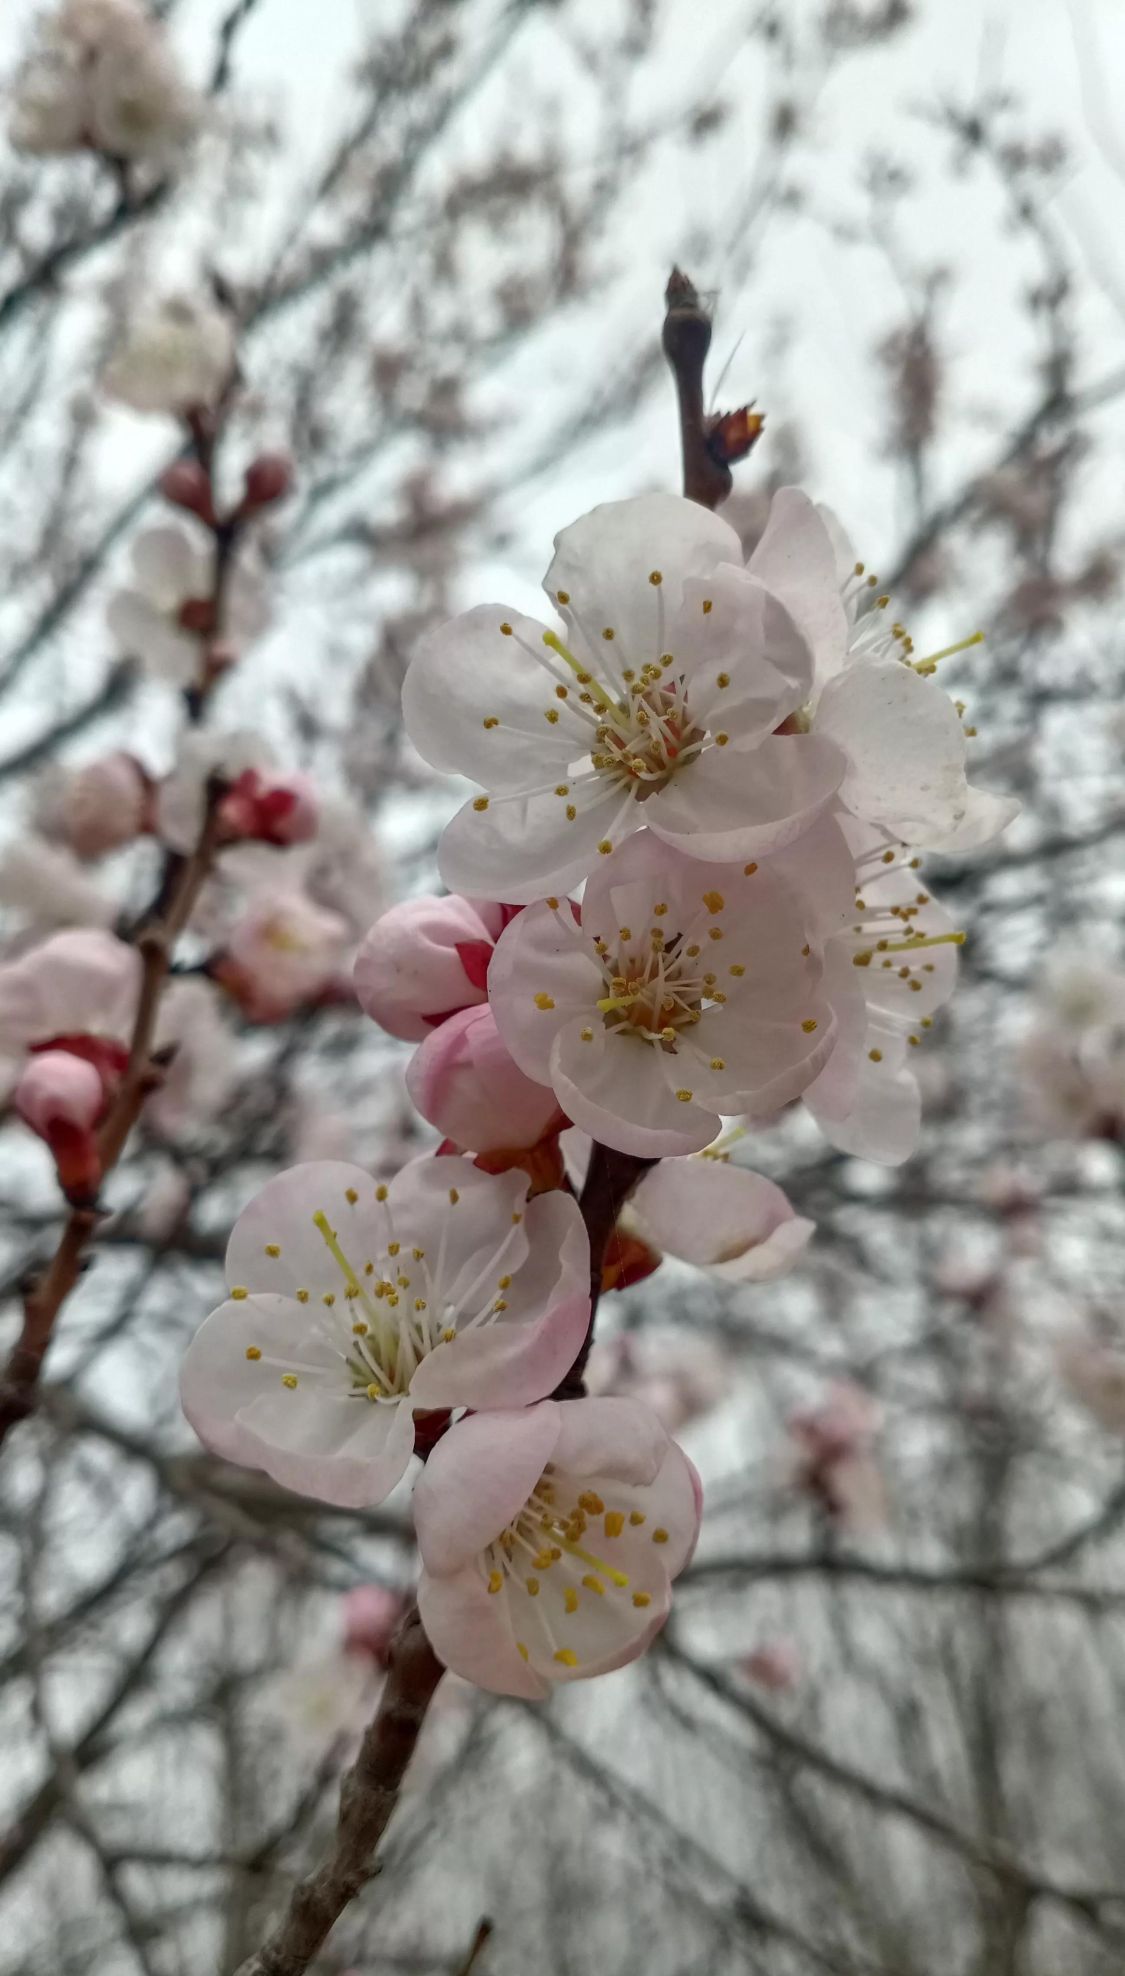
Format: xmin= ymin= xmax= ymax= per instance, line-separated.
xmin=212 ymin=883 xmax=350 ymax=1022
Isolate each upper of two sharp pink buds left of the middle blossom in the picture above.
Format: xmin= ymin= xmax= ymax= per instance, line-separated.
xmin=356 ymin=893 xmax=512 ymax=1043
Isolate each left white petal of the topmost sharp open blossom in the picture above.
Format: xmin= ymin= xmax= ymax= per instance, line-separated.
xmin=401 ymin=605 xmax=573 ymax=786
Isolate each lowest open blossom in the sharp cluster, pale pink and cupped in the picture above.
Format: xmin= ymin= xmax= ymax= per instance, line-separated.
xmin=413 ymin=1399 xmax=702 ymax=1699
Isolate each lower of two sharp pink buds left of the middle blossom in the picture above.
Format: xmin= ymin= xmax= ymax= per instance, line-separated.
xmin=405 ymin=1006 xmax=563 ymax=1152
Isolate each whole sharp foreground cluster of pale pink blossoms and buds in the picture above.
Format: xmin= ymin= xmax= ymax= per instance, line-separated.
xmin=171 ymin=478 xmax=1010 ymax=1695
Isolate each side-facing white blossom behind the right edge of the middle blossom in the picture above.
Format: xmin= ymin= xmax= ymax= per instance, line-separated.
xmin=805 ymin=820 xmax=965 ymax=1166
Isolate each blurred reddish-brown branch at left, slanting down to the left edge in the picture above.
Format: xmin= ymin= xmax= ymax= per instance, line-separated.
xmin=0 ymin=781 xmax=223 ymax=1441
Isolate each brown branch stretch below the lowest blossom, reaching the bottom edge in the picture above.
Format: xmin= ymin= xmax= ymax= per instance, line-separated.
xmin=235 ymin=1606 xmax=445 ymax=1976
